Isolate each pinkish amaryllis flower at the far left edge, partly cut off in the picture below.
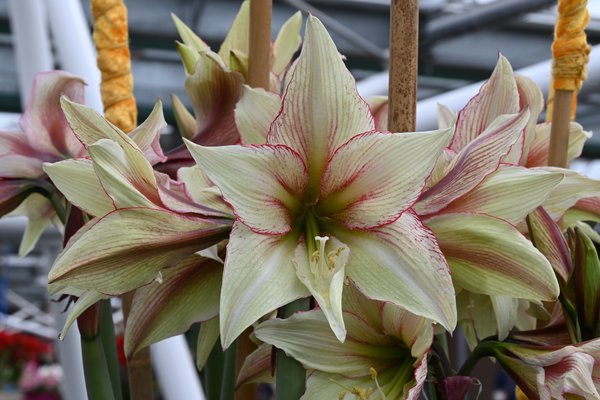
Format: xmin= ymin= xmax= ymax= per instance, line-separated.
xmin=0 ymin=71 xmax=85 ymax=255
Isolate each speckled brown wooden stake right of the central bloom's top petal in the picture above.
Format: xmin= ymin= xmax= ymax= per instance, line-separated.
xmin=388 ymin=0 xmax=419 ymax=132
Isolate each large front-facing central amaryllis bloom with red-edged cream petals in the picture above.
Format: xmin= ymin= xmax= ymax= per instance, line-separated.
xmin=188 ymin=17 xmax=456 ymax=347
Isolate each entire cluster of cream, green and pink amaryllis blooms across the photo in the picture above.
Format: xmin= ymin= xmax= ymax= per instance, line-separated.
xmin=0 ymin=3 xmax=600 ymax=399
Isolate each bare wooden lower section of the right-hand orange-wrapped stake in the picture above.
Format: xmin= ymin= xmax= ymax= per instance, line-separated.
xmin=548 ymin=90 xmax=573 ymax=168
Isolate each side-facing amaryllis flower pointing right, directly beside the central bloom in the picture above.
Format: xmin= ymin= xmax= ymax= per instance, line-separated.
xmin=396 ymin=56 xmax=564 ymax=345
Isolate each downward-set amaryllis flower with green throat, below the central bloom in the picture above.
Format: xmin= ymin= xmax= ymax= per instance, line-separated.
xmin=255 ymin=286 xmax=433 ymax=400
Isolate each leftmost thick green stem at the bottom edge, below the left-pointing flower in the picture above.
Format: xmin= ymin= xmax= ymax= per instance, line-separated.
xmin=81 ymin=336 xmax=115 ymax=400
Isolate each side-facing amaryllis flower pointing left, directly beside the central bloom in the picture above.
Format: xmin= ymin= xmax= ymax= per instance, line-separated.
xmin=44 ymin=100 xmax=231 ymax=354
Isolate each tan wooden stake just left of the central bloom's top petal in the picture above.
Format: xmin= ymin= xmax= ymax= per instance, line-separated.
xmin=248 ymin=0 xmax=272 ymax=89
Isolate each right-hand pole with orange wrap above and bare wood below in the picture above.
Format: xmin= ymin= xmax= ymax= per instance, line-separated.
xmin=548 ymin=0 xmax=590 ymax=168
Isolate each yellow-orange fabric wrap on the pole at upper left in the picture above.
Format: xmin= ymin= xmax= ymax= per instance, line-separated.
xmin=90 ymin=0 xmax=137 ymax=132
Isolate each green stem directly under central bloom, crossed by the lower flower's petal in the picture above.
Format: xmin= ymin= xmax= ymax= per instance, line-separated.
xmin=275 ymin=298 xmax=310 ymax=400
